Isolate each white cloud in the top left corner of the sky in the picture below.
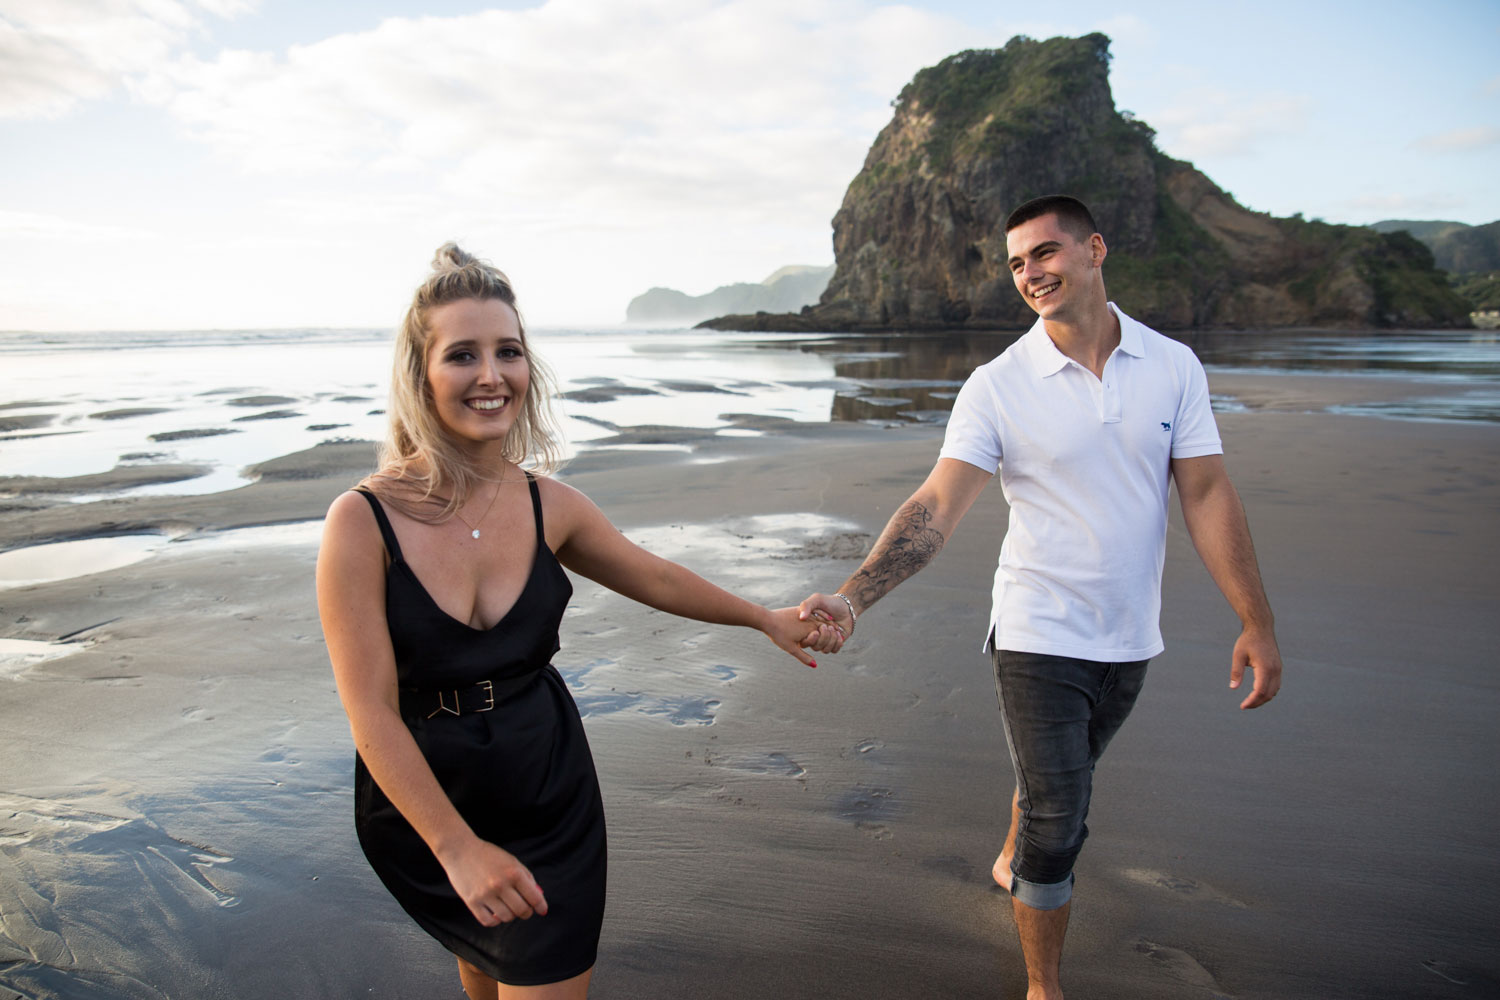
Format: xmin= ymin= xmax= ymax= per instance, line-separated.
xmin=0 ymin=0 xmax=249 ymax=118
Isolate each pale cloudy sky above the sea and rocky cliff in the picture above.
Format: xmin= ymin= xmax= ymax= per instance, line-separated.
xmin=0 ymin=0 xmax=1500 ymax=331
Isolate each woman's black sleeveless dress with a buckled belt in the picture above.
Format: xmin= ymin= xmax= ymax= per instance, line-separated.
xmin=354 ymin=475 xmax=605 ymax=987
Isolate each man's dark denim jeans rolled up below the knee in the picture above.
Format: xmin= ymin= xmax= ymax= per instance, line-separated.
xmin=993 ymin=649 xmax=1149 ymax=910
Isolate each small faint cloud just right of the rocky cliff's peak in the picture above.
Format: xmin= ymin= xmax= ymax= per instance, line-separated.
xmin=1148 ymin=90 xmax=1311 ymax=159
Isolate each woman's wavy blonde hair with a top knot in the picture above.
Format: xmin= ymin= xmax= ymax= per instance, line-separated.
xmin=360 ymin=243 xmax=563 ymax=522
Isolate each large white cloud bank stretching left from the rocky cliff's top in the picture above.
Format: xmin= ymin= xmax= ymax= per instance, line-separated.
xmin=135 ymin=0 xmax=1004 ymax=230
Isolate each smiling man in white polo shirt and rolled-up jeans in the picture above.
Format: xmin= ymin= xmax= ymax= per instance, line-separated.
xmin=803 ymin=195 xmax=1281 ymax=1000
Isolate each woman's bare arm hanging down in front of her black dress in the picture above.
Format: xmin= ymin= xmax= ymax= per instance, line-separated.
xmin=318 ymin=493 xmax=548 ymax=927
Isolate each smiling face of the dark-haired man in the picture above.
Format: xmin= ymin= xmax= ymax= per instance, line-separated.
xmin=1005 ymin=214 xmax=1106 ymax=321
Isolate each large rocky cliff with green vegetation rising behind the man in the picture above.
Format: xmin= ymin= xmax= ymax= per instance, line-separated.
xmin=705 ymin=34 xmax=1467 ymax=330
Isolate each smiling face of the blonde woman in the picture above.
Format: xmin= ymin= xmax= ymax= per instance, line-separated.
xmin=428 ymin=298 xmax=531 ymax=448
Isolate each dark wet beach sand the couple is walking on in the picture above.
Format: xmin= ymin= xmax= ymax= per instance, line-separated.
xmin=0 ymin=375 xmax=1500 ymax=1000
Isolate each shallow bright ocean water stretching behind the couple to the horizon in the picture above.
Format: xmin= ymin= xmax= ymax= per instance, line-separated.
xmin=0 ymin=328 xmax=1500 ymax=501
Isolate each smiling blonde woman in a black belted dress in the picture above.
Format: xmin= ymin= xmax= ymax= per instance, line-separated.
xmin=318 ymin=243 xmax=837 ymax=1000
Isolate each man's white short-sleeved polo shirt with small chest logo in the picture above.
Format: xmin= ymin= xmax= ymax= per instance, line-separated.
xmin=942 ymin=303 xmax=1224 ymax=663
